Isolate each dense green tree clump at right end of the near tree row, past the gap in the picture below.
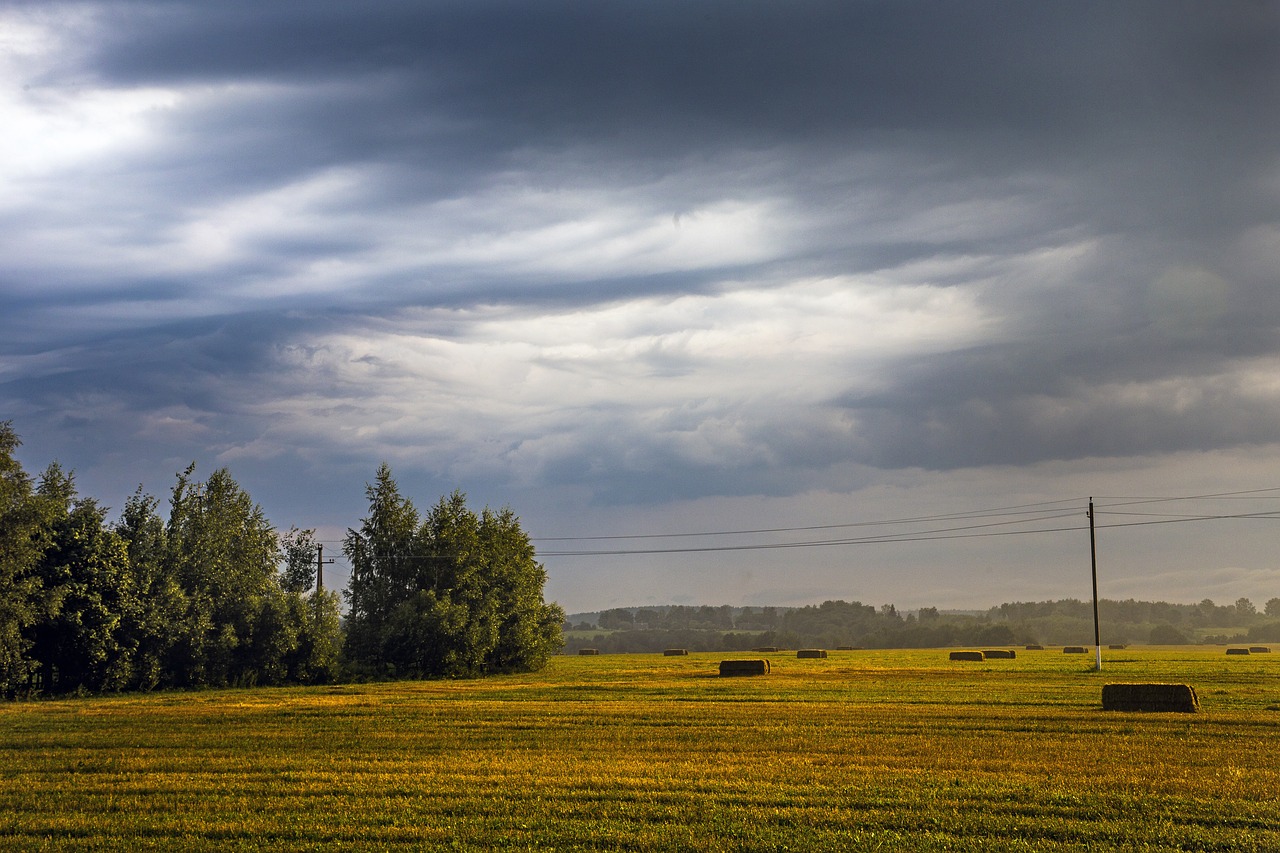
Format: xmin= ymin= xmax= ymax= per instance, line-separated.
xmin=343 ymin=464 xmax=564 ymax=676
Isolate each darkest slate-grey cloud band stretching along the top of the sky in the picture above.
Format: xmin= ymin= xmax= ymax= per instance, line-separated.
xmin=67 ymin=3 xmax=1280 ymax=206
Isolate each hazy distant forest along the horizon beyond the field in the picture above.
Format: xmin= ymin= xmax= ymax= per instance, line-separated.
xmin=564 ymin=598 xmax=1280 ymax=653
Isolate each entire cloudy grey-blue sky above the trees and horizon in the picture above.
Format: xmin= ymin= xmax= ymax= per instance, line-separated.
xmin=0 ymin=0 xmax=1280 ymax=612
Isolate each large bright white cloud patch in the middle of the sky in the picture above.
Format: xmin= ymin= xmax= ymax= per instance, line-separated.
xmin=247 ymin=272 xmax=992 ymax=480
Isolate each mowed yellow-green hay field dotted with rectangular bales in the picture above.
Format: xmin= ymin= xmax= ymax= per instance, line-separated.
xmin=0 ymin=648 xmax=1280 ymax=850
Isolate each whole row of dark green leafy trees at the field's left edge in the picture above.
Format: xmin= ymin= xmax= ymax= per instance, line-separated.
xmin=0 ymin=421 xmax=563 ymax=697
